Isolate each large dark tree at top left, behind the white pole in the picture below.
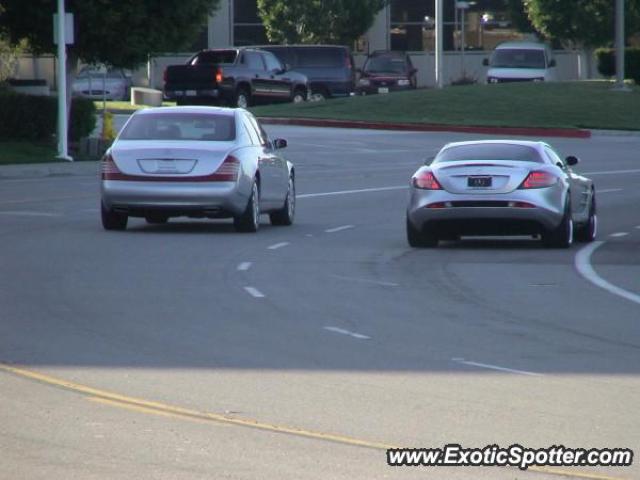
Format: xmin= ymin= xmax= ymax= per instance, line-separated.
xmin=0 ymin=0 xmax=219 ymax=68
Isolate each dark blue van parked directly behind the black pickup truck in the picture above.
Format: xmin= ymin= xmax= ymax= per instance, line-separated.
xmin=258 ymin=45 xmax=355 ymax=100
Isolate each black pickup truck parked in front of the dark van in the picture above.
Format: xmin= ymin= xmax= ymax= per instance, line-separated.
xmin=164 ymin=48 xmax=308 ymax=108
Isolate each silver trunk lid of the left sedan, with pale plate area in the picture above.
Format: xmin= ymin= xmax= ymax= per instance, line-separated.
xmin=111 ymin=140 xmax=234 ymax=177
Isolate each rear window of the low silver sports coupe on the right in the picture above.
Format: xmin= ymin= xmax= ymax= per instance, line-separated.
xmin=434 ymin=143 xmax=544 ymax=163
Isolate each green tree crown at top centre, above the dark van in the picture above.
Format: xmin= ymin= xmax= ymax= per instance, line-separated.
xmin=257 ymin=0 xmax=388 ymax=45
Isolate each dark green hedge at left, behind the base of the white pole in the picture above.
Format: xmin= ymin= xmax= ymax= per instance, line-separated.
xmin=0 ymin=89 xmax=96 ymax=142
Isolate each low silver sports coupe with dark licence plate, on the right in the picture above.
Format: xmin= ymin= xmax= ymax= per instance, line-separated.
xmin=406 ymin=140 xmax=597 ymax=248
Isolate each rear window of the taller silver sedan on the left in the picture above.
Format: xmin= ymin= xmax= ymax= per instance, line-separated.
xmin=119 ymin=113 xmax=236 ymax=142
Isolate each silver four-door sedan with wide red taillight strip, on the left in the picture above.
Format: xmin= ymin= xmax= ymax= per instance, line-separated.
xmin=101 ymin=107 xmax=296 ymax=232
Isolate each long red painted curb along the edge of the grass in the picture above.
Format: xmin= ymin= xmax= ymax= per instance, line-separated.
xmin=260 ymin=117 xmax=591 ymax=138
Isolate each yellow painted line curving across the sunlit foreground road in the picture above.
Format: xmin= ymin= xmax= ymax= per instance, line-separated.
xmin=0 ymin=363 xmax=624 ymax=480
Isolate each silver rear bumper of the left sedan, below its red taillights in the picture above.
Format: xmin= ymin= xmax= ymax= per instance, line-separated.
xmin=101 ymin=180 xmax=250 ymax=217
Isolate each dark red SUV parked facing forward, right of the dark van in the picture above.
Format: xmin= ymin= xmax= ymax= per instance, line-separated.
xmin=356 ymin=50 xmax=417 ymax=95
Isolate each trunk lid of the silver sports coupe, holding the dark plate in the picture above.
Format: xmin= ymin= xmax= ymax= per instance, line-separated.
xmin=432 ymin=160 xmax=530 ymax=195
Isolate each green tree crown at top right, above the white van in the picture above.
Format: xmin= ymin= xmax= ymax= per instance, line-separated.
xmin=524 ymin=0 xmax=640 ymax=50
